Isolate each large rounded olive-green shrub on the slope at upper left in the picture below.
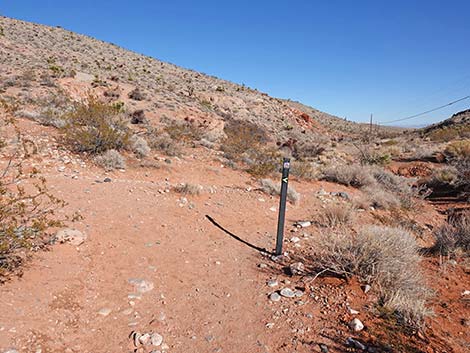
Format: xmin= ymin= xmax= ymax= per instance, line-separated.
xmin=62 ymin=95 xmax=130 ymax=154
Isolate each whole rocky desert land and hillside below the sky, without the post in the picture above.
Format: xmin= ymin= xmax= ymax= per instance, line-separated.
xmin=0 ymin=17 xmax=470 ymax=353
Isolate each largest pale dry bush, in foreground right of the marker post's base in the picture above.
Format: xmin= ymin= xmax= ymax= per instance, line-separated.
xmin=311 ymin=226 xmax=429 ymax=326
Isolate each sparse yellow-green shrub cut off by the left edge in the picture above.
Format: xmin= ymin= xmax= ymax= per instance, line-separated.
xmin=0 ymin=124 xmax=73 ymax=282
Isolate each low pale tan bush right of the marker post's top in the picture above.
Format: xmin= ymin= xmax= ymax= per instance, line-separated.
xmin=323 ymin=165 xmax=376 ymax=187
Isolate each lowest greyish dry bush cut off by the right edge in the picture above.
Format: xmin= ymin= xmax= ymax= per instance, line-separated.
xmin=430 ymin=211 xmax=470 ymax=256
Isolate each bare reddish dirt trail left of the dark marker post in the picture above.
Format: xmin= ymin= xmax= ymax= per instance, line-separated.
xmin=0 ymin=155 xmax=316 ymax=352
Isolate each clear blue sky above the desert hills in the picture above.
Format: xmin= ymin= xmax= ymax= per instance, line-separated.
xmin=0 ymin=0 xmax=470 ymax=125
